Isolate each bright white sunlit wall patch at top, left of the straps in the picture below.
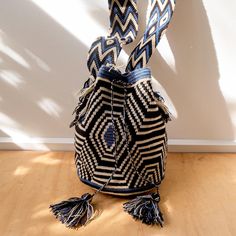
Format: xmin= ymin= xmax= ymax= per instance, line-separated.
xmin=31 ymin=0 xmax=107 ymax=47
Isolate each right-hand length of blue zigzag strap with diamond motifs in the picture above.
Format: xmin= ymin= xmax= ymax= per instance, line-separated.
xmin=126 ymin=0 xmax=175 ymax=71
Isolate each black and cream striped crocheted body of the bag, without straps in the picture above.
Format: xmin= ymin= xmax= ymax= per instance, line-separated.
xmin=75 ymin=69 xmax=167 ymax=193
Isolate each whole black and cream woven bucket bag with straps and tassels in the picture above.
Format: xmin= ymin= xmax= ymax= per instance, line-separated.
xmin=50 ymin=0 xmax=175 ymax=227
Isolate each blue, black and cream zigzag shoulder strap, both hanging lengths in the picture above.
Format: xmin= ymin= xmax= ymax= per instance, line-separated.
xmin=80 ymin=0 xmax=175 ymax=99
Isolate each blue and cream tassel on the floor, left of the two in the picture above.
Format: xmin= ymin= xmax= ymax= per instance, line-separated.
xmin=49 ymin=193 xmax=94 ymax=228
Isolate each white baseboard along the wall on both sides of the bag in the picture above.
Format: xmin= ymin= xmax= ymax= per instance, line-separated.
xmin=0 ymin=137 xmax=236 ymax=152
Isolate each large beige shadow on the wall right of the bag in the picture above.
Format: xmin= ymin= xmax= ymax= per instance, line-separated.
xmin=149 ymin=0 xmax=234 ymax=140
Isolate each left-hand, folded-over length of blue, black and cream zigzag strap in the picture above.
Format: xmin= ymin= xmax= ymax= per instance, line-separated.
xmin=87 ymin=0 xmax=138 ymax=79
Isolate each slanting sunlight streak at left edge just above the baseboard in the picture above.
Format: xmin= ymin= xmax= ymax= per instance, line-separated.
xmin=0 ymin=112 xmax=49 ymax=151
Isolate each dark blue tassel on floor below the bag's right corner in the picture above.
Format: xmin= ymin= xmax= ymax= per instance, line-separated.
xmin=123 ymin=193 xmax=164 ymax=227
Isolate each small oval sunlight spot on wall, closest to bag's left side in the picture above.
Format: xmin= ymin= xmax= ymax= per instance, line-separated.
xmin=37 ymin=98 xmax=62 ymax=118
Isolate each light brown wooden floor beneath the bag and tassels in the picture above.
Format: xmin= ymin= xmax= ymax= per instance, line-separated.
xmin=0 ymin=151 xmax=236 ymax=236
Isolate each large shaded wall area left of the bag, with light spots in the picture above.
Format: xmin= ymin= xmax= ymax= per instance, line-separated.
xmin=0 ymin=1 xmax=92 ymax=147
